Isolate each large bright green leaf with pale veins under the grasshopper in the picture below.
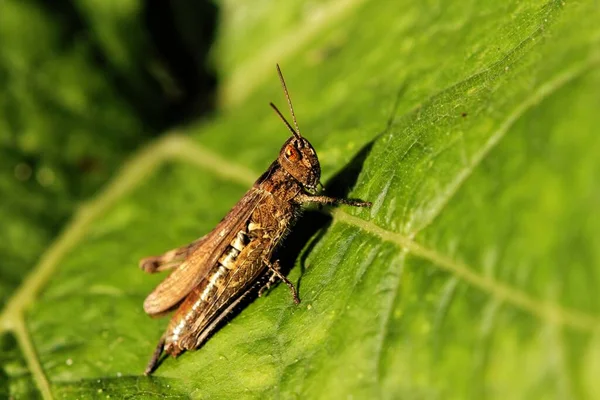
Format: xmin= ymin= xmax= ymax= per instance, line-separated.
xmin=0 ymin=0 xmax=600 ymax=399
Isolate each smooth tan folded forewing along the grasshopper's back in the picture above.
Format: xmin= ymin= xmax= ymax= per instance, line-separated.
xmin=144 ymin=188 xmax=269 ymax=315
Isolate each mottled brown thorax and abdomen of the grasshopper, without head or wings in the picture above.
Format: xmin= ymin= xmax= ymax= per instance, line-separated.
xmin=164 ymin=163 xmax=302 ymax=356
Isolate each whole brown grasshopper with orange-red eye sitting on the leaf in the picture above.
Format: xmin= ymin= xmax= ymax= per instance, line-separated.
xmin=140 ymin=65 xmax=371 ymax=375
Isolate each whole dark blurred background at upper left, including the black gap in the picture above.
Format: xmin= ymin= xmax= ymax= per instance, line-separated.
xmin=0 ymin=0 xmax=218 ymax=303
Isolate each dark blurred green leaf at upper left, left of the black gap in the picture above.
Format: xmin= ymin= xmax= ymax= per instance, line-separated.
xmin=0 ymin=0 xmax=145 ymax=304
